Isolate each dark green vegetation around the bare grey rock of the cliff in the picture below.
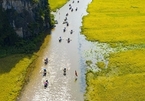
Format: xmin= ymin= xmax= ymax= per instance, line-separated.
xmin=0 ymin=0 xmax=52 ymax=57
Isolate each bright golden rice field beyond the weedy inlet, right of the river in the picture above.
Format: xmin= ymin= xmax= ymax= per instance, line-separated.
xmin=82 ymin=0 xmax=145 ymax=44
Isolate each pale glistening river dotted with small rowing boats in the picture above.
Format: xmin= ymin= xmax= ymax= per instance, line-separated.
xmin=18 ymin=0 xmax=91 ymax=101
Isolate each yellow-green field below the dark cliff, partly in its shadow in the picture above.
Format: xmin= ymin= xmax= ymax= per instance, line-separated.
xmin=0 ymin=54 xmax=36 ymax=101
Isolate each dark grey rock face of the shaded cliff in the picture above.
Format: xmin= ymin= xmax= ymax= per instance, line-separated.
xmin=0 ymin=0 xmax=51 ymax=38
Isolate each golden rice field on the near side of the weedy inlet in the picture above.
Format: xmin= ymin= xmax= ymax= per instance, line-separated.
xmin=85 ymin=49 xmax=145 ymax=101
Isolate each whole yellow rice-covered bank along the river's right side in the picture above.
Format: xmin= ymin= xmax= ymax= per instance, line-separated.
xmin=82 ymin=0 xmax=145 ymax=101
